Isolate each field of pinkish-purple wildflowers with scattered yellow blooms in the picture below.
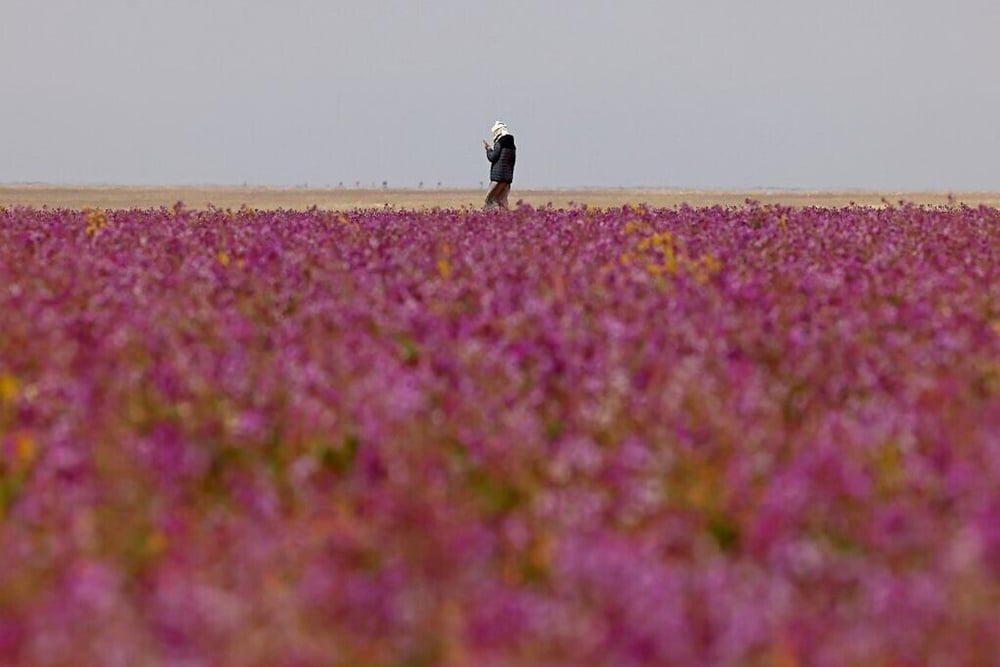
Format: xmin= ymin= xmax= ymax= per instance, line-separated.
xmin=0 ymin=201 xmax=1000 ymax=667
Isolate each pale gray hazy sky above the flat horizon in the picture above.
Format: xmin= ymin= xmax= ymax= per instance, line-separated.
xmin=0 ymin=0 xmax=1000 ymax=190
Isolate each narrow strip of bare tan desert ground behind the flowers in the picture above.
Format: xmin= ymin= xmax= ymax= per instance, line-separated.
xmin=0 ymin=184 xmax=1000 ymax=210
